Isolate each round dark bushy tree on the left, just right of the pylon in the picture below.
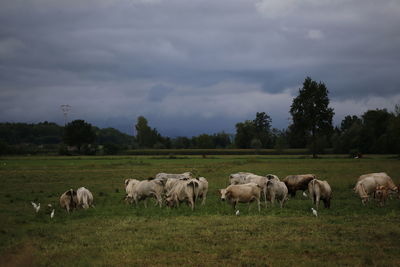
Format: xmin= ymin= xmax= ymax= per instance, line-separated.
xmin=63 ymin=120 xmax=96 ymax=152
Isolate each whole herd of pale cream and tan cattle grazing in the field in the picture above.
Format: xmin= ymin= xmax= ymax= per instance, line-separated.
xmin=54 ymin=172 xmax=399 ymax=216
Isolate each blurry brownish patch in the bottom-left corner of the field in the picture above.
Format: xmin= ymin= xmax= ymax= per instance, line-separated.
xmin=0 ymin=242 xmax=35 ymax=267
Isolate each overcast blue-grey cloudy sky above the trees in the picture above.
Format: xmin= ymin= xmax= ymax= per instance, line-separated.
xmin=0 ymin=0 xmax=400 ymax=137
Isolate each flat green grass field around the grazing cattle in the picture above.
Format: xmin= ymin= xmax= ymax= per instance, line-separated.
xmin=0 ymin=155 xmax=400 ymax=266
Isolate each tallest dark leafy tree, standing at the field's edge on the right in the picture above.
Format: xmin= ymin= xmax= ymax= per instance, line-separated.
xmin=290 ymin=77 xmax=334 ymax=158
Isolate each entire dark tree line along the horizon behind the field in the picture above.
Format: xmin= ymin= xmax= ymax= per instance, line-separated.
xmin=0 ymin=77 xmax=400 ymax=157
